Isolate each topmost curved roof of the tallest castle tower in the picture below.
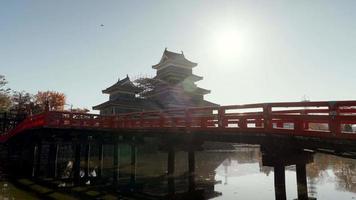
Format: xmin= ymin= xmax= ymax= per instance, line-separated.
xmin=152 ymin=48 xmax=198 ymax=69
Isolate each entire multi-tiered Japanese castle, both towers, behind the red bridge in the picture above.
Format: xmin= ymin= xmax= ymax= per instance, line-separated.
xmin=93 ymin=49 xmax=217 ymax=115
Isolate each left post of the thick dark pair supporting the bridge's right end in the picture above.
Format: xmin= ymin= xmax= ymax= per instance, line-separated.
xmin=274 ymin=164 xmax=287 ymax=200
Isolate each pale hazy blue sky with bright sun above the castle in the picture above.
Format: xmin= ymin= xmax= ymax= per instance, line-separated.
xmin=0 ymin=0 xmax=356 ymax=111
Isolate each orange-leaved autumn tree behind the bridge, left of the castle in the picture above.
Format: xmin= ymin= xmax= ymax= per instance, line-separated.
xmin=35 ymin=91 xmax=66 ymax=112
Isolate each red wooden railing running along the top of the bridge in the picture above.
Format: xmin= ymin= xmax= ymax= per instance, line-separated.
xmin=0 ymin=101 xmax=356 ymax=142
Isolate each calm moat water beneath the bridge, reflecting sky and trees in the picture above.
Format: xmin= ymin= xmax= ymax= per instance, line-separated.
xmin=0 ymin=141 xmax=356 ymax=200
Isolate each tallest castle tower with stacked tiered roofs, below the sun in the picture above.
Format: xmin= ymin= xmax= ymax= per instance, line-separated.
xmin=148 ymin=49 xmax=217 ymax=109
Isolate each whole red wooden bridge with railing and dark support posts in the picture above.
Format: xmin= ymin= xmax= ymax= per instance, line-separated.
xmin=0 ymin=101 xmax=356 ymax=199
